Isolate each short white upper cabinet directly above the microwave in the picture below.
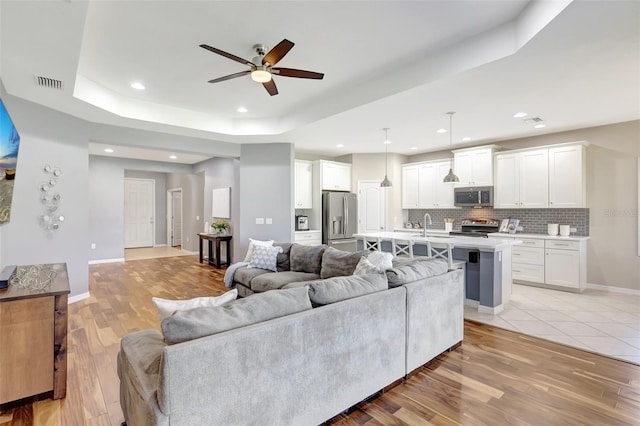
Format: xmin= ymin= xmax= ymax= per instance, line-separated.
xmin=453 ymin=145 xmax=497 ymax=187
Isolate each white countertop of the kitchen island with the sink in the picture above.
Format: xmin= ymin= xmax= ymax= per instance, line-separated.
xmin=353 ymin=229 xmax=521 ymax=251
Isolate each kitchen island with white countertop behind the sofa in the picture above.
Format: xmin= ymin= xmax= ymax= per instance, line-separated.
xmin=354 ymin=232 xmax=520 ymax=314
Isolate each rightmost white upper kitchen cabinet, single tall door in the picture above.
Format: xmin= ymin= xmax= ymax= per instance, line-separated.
xmin=549 ymin=145 xmax=586 ymax=208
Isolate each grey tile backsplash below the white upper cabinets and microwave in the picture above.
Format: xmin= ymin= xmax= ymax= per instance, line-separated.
xmin=408 ymin=207 xmax=589 ymax=236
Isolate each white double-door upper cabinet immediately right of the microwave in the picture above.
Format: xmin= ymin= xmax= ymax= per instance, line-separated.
xmin=494 ymin=148 xmax=549 ymax=208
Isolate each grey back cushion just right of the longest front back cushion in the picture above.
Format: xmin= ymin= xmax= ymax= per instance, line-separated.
xmin=306 ymin=274 xmax=389 ymax=305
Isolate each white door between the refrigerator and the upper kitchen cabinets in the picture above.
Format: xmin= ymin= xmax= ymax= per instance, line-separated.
xmin=358 ymin=181 xmax=387 ymax=232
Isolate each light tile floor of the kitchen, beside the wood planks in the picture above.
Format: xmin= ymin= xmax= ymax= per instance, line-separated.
xmin=464 ymin=284 xmax=640 ymax=364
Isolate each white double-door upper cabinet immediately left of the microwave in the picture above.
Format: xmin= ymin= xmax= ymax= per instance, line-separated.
xmin=402 ymin=161 xmax=453 ymax=209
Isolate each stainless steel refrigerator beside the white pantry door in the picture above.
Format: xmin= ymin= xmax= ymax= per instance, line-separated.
xmin=322 ymin=192 xmax=358 ymax=251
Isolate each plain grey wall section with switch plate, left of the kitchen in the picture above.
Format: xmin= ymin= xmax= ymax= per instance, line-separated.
xmin=239 ymin=143 xmax=294 ymax=259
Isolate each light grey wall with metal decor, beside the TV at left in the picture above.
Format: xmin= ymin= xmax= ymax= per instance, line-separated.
xmin=0 ymin=96 xmax=89 ymax=296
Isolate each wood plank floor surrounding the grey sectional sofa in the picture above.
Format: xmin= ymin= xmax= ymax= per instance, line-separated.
xmin=0 ymin=256 xmax=640 ymax=426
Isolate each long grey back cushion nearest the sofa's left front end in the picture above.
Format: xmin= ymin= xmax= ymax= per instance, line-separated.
xmin=162 ymin=287 xmax=311 ymax=344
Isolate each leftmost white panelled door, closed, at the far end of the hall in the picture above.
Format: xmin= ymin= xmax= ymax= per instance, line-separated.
xmin=124 ymin=179 xmax=155 ymax=248
